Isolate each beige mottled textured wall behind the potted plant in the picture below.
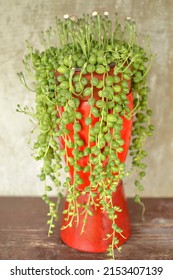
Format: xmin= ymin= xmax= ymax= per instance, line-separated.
xmin=0 ymin=0 xmax=173 ymax=197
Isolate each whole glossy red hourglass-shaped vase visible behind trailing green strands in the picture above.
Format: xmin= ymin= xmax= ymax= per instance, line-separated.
xmin=59 ymin=69 xmax=133 ymax=252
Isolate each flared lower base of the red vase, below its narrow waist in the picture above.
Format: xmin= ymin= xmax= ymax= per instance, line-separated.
xmin=60 ymin=181 xmax=130 ymax=253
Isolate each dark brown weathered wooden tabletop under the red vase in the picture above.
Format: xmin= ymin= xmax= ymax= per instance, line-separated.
xmin=0 ymin=197 xmax=173 ymax=260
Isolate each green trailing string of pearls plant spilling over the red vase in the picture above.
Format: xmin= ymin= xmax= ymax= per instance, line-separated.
xmin=17 ymin=12 xmax=154 ymax=256
